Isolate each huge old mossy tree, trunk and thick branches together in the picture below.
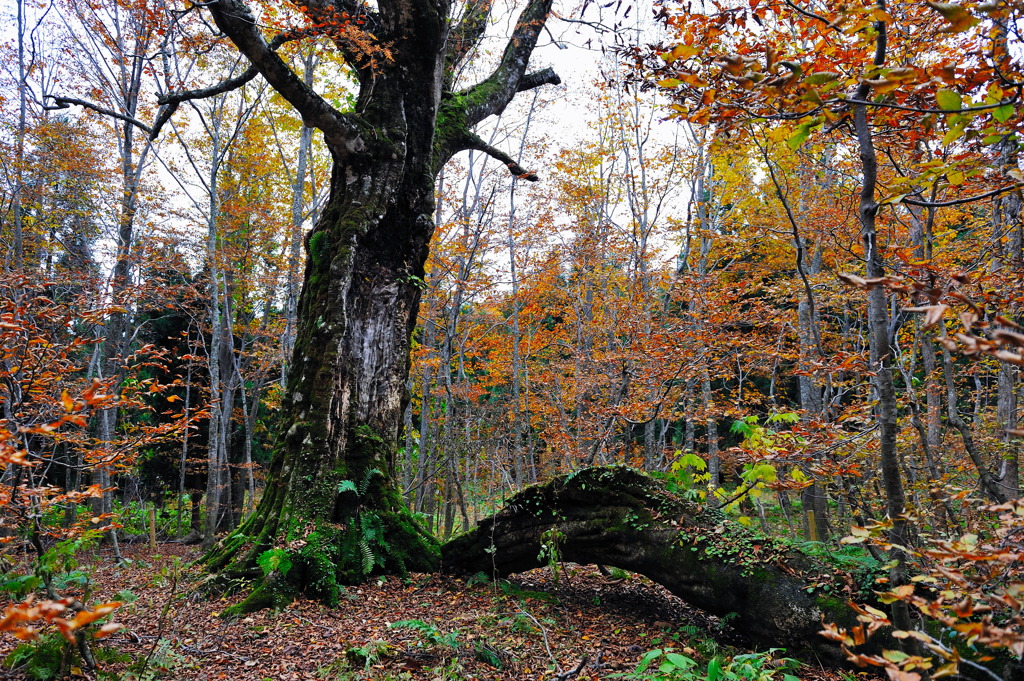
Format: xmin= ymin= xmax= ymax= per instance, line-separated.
xmin=178 ymin=0 xmax=558 ymax=611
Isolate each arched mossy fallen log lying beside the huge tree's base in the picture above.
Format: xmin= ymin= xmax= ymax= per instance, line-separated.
xmin=441 ymin=467 xmax=853 ymax=664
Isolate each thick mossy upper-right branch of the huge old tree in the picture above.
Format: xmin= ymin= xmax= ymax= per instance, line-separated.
xmin=461 ymin=0 xmax=557 ymax=128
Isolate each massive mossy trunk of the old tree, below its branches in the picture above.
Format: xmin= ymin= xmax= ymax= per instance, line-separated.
xmin=208 ymin=139 xmax=446 ymax=609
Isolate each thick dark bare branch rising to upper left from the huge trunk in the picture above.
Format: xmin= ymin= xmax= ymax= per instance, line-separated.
xmin=206 ymin=0 xmax=355 ymax=144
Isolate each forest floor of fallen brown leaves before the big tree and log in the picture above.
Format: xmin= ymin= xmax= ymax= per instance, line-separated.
xmin=0 ymin=544 xmax=868 ymax=681
